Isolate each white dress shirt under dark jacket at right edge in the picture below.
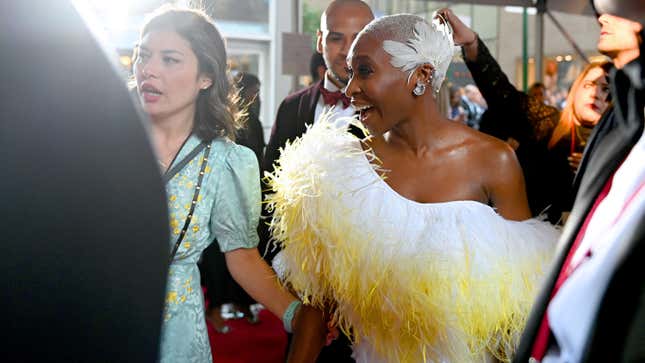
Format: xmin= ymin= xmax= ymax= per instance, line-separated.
xmin=542 ymin=126 xmax=645 ymax=363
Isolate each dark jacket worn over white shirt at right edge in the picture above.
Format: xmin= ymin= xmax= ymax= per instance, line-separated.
xmin=513 ymin=57 xmax=645 ymax=363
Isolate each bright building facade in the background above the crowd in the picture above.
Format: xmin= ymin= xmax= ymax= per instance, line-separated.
xmin=83 ymin=0 xmax=599 ymax=139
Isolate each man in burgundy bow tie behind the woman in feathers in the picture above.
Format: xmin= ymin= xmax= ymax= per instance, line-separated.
xmin=259 ymin=0 xmax=374 ymax=363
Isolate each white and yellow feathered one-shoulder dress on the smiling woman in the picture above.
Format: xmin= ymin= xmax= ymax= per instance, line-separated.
xmin=267 ymin=117 xmax=558 ymax=363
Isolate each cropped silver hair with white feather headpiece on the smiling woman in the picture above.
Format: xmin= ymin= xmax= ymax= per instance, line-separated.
xmin=356 ymin=14 xmax=454 ymax=93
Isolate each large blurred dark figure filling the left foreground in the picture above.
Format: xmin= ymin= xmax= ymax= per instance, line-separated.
xmin=0 ymin=1 xmax=168 ymax=362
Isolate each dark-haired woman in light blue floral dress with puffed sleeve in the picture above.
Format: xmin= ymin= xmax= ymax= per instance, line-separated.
xmin=134 ymin=8 xmax=324 ymax=363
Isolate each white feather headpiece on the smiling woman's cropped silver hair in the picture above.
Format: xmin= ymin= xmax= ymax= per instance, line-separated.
xmin=383 ymin=14 xmax=455 ymax=93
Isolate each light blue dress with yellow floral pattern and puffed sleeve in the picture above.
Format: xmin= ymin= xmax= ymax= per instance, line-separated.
xmin=160 ymin=135 xmax=261 ymax=363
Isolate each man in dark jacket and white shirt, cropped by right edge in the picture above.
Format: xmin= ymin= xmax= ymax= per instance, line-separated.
xmin=514 ymin=0 xmax=645 ymax=363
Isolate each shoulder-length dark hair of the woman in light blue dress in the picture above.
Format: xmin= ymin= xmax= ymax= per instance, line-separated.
xmin=135 ymin=6 xmax=244 ymax=141
